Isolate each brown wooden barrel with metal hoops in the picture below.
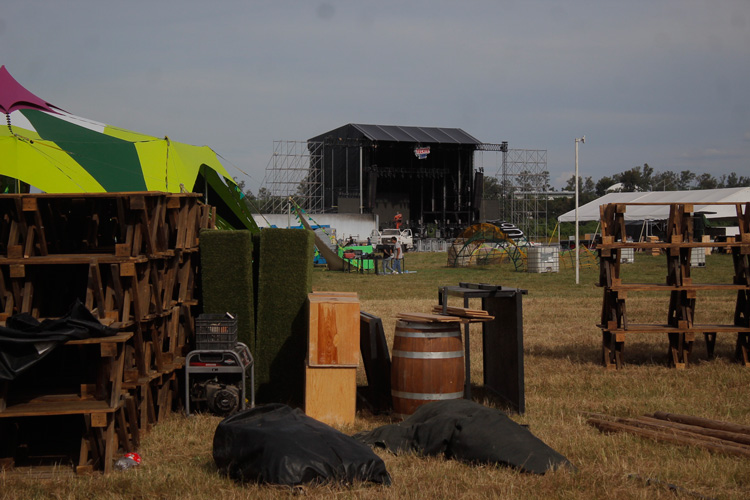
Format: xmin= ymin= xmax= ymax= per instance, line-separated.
xmin=391 ymin=321 xmax=465 ymax=418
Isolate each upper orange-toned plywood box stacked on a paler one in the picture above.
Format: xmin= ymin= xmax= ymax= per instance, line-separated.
xmin=307 ymin=293 xmax=359 ymax=367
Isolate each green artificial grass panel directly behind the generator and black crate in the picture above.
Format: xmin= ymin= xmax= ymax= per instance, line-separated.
xmin=200 ymin=229 xmax=255 ymax=350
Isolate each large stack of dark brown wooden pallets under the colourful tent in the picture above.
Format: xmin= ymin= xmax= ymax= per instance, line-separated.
xmin=0 ymin=192 xmax=215 ymax=471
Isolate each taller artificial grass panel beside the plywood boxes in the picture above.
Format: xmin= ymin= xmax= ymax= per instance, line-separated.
xmin=254 ymin=228 xmax=314 ymax=405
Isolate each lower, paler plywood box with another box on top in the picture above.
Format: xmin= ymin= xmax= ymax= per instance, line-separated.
xmin=305 ymin=366 xmax=357 ymax=424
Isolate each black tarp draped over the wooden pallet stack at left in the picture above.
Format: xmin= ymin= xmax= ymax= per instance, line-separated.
xmin=0 ymin=300 xmax=117 ymax=380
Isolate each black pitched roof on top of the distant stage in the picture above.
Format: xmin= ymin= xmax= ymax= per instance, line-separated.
xmin=308 ymin=123 xmax=482 ymax=146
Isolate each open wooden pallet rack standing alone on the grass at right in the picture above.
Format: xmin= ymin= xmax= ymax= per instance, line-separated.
xmin=597 ymin=202 xmax=750 ymax=369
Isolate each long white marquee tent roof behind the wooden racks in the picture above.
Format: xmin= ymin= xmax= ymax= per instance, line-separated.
xmin=557 ymin=187 xmax=750 ymax=222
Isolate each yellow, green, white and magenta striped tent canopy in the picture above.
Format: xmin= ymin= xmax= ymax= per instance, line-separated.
xmin=0 ymin=66 xmax=257 ymax=228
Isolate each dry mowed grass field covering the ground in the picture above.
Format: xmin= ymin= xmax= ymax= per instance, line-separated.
xmin=0 ymin=253 xmax=750 ymax=499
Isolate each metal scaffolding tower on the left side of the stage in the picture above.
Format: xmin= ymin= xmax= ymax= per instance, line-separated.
xmin=260 ymin=141 xmax=323 ymax=214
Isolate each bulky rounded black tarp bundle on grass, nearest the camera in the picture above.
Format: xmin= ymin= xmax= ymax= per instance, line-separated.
xmin=213 ymin=404 xmax=391 ymax=486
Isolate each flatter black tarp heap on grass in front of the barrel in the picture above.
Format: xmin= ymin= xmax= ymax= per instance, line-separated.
xmin=354 ymin=399 xmax=575 ymax=474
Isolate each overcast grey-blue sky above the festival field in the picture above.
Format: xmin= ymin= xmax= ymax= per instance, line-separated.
xmin=0 ymin=0 xmax=750 ymax=192
